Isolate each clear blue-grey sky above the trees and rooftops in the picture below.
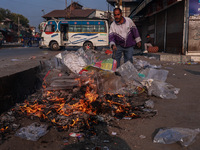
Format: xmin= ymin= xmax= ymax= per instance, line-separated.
xmin=0 ymin=0 xmax=111 ymax=28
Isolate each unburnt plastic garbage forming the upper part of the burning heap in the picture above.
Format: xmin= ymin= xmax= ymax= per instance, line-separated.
xmin=45 ymin=48 xmax=180 ymax=99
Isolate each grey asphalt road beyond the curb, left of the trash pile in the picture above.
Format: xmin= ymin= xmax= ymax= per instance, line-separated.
xmin=0 ymin=47 xmax=66 ymax=77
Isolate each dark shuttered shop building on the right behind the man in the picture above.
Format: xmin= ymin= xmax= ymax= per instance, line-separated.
xmin=129 ymin=0 xmax=200 ymax=55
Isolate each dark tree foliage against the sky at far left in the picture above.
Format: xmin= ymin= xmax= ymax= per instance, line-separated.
xmin=0 ymin=8 xmax=29 ymax=27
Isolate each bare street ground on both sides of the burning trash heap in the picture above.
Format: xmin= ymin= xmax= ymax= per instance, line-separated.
xmin=0 ymin=48 xmax=200 ymax=150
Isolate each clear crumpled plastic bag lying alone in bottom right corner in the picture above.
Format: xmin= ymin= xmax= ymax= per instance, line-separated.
xmin=153 ymin=128 xmax=200 ymax=147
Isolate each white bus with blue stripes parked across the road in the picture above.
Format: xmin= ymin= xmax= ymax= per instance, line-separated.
xmin=39 ymin=19 xmax=109 ymax=50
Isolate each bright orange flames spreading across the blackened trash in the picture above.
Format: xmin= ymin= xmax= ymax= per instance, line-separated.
xmin=17 ymin=73 xmax=137 ymax=131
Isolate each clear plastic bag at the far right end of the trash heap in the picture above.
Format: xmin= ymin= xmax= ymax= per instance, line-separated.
xmin=147 ymin=81 xmax=180 ymax=99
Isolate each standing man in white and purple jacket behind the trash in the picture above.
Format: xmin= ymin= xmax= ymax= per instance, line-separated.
xmin=109 ymin=8 xmax=141 ymax=67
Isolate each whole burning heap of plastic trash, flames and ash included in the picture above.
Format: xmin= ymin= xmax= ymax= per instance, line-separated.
xmin=0 ymin=49 xmax=179 ymax=144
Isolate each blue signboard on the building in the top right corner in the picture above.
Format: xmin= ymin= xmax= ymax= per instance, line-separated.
xmin=189 ymin=0 xmax=200 ymax=16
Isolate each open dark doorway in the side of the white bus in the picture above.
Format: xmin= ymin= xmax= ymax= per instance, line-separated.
xmin=60 ymin=24 xmax=69 ymax=45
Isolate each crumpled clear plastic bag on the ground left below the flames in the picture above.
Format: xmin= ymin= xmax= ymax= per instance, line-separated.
xmin=15 ymin=122 xmax=48 ymax=141
